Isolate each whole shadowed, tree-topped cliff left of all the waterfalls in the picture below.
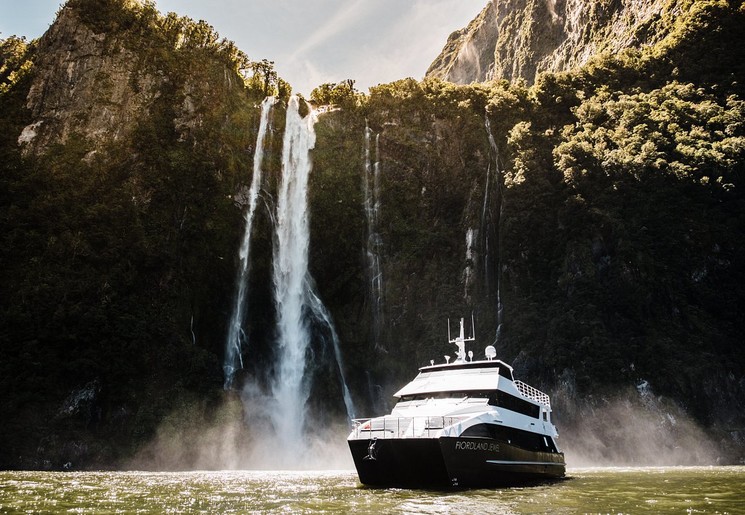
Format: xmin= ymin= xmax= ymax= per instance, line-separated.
xmin=0 ymin=0 xmax=276 ymax=468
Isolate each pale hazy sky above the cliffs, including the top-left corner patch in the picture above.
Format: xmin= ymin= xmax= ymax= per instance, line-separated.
xmin=0 ymin=0 xmax=488 ymax=95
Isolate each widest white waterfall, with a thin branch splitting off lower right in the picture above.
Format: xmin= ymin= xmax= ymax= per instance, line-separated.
xmin=271 ymin=96 xmax=353 ymax=452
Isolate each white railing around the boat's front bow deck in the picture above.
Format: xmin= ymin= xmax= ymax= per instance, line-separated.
xmin=352 ymin=416 xmax=464 ymax=439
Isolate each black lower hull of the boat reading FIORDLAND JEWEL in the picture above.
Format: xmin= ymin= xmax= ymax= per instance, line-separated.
xmin=349 ymin=437 xmax=565 ymax=488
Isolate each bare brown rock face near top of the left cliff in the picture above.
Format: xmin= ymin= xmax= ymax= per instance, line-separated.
xmin=18 ymin=8 xmax=162 ymax=153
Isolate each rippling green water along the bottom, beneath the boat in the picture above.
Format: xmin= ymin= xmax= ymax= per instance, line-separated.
xmin=0 ymin=467 xmax=745 ymax=514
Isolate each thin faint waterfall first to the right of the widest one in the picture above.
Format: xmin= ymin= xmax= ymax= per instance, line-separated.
xmin=362 ymin=123 xmax=383 ymax=350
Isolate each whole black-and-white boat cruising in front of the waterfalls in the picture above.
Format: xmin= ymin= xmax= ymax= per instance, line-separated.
xmin=347 ymin=319 xmax=565 ymax=489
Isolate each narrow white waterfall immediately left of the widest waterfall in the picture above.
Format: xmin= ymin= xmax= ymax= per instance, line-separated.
xmin=223 ymin=97 xmax=275 ymax=390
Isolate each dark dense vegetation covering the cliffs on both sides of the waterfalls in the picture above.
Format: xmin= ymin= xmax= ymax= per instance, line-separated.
xmin=0 ymin=0 xmax=745 ymax=467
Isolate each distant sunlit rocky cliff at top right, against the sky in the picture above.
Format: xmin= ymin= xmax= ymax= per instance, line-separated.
xmin=427 ymin=0 xmax=680 ymax=84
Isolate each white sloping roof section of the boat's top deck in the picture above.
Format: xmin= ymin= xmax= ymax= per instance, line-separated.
xmin=393 ymin=360 xmax=513 ymax=397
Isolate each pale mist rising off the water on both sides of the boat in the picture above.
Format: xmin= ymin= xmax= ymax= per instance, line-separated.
xmin=126 ymin=370 xmax=727 ymax=470
